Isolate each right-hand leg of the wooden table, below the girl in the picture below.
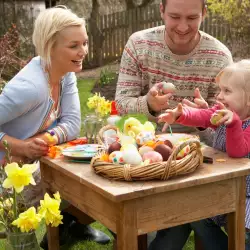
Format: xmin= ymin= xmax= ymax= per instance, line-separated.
xmin=228 ymin=177 xmax=246 ymax=250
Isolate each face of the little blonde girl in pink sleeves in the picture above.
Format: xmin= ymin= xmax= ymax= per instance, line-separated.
xmin=217 ymin=75 xmax=249 ymax=120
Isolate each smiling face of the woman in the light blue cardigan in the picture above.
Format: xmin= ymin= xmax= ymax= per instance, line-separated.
xmin=51 ymin=25 xmax=88 ymax=75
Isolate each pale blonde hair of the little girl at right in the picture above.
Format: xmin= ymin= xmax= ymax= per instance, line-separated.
xmin=216 ymin=59 xmax=250 ymax=105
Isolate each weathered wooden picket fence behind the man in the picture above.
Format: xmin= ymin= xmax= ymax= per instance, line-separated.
xmin=85 ymin=4 xmax=227 ymax=67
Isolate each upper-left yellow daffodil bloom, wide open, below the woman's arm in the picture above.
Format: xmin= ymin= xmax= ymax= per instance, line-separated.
xmin=3 ymin=162 xmax=38 ymax=193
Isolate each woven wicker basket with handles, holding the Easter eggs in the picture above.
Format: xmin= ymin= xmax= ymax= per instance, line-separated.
xmin=90 ymin=126 xmax=203 ymax=181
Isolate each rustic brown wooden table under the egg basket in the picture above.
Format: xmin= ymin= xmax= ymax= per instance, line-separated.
xmin=41 ymin=147 xmax=250 ymax=250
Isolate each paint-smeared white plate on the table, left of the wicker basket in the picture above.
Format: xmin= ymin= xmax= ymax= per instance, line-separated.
xmin=62 ymin=144 xmax=102 ymax=160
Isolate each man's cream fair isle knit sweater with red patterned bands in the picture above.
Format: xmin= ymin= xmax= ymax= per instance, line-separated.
xmin=116 ymin=25 xmax=233 ymax=132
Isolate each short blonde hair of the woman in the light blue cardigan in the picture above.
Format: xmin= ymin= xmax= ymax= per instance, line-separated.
xmin=32 ymin=5 xmax=85 ymax=67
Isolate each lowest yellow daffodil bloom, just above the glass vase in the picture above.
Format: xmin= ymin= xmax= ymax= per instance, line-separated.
xmin=12 ymin=207 xmax=42 ymax=232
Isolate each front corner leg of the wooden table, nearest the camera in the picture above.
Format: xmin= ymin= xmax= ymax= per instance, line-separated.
xmin=116 ymin=201 xmax=138 ymax=250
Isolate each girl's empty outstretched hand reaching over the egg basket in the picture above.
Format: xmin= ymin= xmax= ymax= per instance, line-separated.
xmin=158 ymin=103 xmax=183 ymax=132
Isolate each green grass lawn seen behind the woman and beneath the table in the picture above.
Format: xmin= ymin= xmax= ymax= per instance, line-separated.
xmin=0 ymin=79 xmax=194 ymax=250
